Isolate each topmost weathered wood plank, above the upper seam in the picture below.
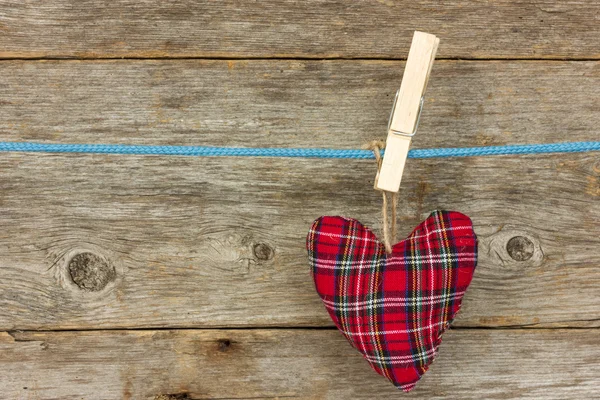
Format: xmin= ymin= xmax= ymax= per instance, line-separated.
xmin=0 ymin=0 xmax=600 ymax=59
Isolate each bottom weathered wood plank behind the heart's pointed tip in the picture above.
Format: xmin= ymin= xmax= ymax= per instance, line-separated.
xmin=0 ymin=329 xmax=600 ymax=400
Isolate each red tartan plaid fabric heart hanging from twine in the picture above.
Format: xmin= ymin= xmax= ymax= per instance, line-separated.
xmin=307 ymin=211 xmax=477 ymax=392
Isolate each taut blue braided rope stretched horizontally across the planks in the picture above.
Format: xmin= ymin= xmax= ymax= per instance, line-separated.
xmin=0 ymin=142 xmax=600 ymax=159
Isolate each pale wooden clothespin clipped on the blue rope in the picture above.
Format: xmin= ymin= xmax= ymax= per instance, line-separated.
xmin=375 ymin=31 xmax=440 ymax=192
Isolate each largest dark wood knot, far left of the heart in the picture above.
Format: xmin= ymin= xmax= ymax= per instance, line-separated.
xmin=68 ymin=252 xmax=117 ymax=292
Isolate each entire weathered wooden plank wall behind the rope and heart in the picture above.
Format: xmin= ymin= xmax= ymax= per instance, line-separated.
xmin=0 ymin=0 xmax=600 ymax=400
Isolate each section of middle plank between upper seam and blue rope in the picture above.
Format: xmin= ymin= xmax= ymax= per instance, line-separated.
xmin=0 ymin=60 xmax=600 ymax=148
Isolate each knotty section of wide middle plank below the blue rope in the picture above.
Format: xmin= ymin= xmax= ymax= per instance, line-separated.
xmin=0 ymin=153 xmax=600 ymax=330
